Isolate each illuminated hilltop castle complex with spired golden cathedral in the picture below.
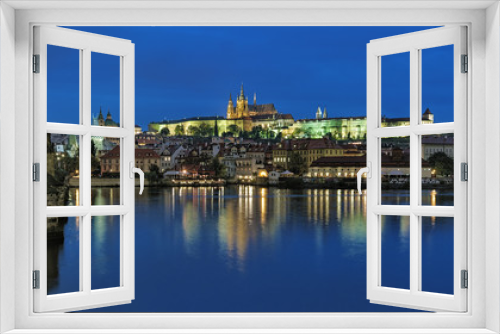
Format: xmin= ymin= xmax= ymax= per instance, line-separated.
xmin=149 ymin=85 xmax=434 ymax=140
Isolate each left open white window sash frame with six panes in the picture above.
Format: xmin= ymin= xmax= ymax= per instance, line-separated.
xmin=33 ymin=26 xmax=135 ymax=312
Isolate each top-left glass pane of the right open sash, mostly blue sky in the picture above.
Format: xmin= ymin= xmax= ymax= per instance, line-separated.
xmin=380 ymin=52 xmax=410 ymax=127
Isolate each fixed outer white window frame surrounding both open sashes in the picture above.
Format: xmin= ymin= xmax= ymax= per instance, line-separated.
xmin=0 ymin=0 xmax=500 ymax=333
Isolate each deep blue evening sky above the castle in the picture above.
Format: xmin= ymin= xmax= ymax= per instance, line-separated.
xmin=48 ymin=27 xmax=453 ymax=128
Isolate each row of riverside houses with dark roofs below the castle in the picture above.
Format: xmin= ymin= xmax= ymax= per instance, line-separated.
xmin=96 ymin=133 xmax=453 ymax=180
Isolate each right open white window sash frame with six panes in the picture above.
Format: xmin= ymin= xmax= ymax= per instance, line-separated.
xmin=366 ymin=25 xmax=469 ymax=312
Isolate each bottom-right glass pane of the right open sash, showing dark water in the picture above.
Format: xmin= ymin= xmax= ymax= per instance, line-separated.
xmin=422 ymin=217 xmax=453 ymax=294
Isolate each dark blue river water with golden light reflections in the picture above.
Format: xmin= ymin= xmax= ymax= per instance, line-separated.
xmin=49 ymin=186 xmax=453 ymax=312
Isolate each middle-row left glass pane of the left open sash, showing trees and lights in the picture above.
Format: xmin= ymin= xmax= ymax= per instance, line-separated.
xmin=47 ymin=133 xmax=80 ymax=206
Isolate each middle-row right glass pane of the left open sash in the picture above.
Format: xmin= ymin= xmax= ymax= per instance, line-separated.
xmin=91 ymin=136 xmax=121 ymax=205
